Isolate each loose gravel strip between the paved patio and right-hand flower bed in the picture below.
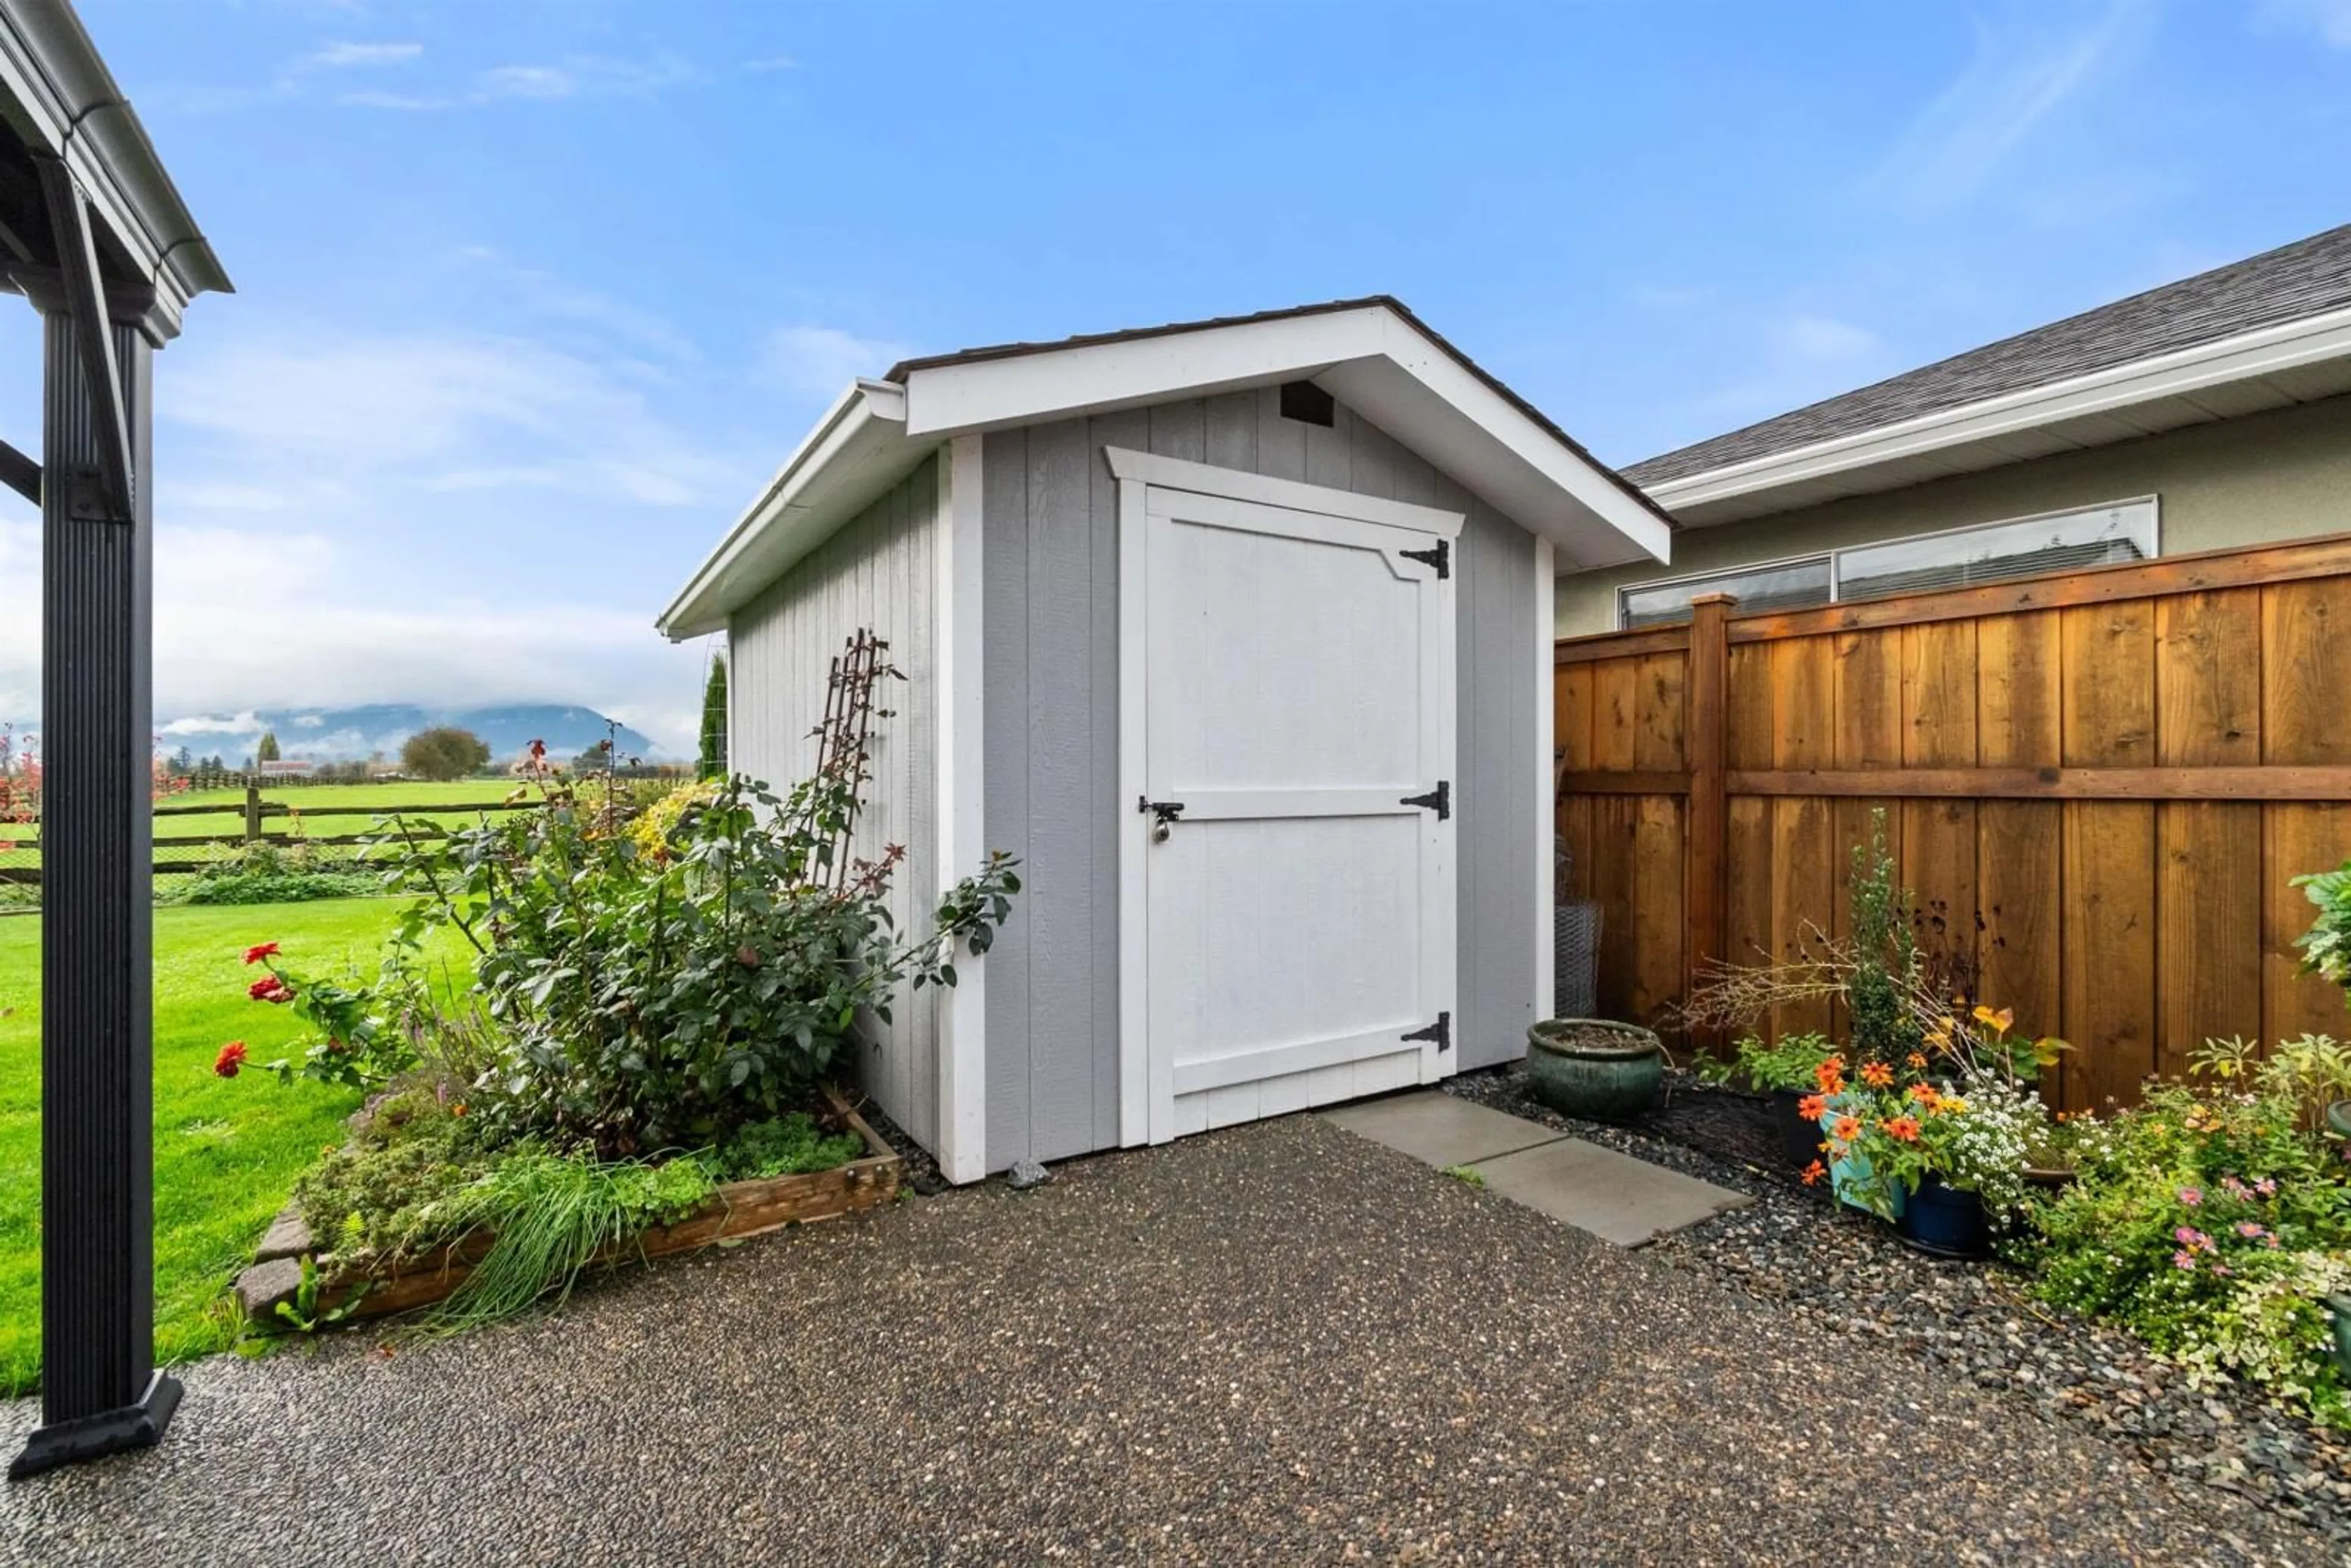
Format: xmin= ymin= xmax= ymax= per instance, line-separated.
xmin=1448 ymin=1067 xmax=2351 ymax=1559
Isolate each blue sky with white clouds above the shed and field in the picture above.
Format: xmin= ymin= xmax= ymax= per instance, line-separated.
xmin=0 ymin=0 xmax=2351 ymax=745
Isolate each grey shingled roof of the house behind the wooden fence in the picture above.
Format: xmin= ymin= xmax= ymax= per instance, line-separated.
xmin=1624 ymin=223 xmax=2351 ymax=487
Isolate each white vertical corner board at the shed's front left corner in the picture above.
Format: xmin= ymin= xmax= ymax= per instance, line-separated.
xmin=933 ymin=435 xmax=988 ymax=1182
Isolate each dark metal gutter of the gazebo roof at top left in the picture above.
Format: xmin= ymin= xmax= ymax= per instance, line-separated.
xmin=0 ymin=0 xmax=235 ymax=334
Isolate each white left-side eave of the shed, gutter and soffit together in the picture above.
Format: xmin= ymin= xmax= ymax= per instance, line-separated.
xmin=654 ymin=381 xmax=938 ymax=642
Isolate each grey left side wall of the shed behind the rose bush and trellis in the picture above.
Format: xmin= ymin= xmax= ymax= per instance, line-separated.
xmin=727 ymin=456 xmax=936 ymax=1147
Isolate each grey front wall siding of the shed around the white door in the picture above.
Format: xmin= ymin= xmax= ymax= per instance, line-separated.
xmin=987 ymin=388 xmax=1550 ymax=1171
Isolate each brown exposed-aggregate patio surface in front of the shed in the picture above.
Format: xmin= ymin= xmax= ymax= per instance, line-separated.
xmin=0 ymin=1117 xmax=2325 ymax=1568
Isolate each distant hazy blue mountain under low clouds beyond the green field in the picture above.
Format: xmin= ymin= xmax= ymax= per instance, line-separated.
xmin=155 ymin=703 xmax=658 ymax=767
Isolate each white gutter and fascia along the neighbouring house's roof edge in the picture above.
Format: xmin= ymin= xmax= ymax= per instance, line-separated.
xmin=1643 ymin=297 xmax=2351 ymax=510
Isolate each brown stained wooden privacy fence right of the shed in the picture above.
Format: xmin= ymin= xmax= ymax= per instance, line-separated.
xmin=1554 ymin=536 xmax=2351 ymax=1107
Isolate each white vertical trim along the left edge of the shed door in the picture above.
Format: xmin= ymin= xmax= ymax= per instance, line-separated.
xmin=1109 ymin=465 xmax=1157 ymax=1150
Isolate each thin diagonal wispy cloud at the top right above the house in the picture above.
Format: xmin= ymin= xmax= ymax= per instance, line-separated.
xmin=1864 ymin=0 xmax=2153 ymax=216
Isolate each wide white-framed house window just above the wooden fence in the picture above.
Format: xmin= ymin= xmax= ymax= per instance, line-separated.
xmin=1618 ymin=496 xmax=2156 ymax=630
